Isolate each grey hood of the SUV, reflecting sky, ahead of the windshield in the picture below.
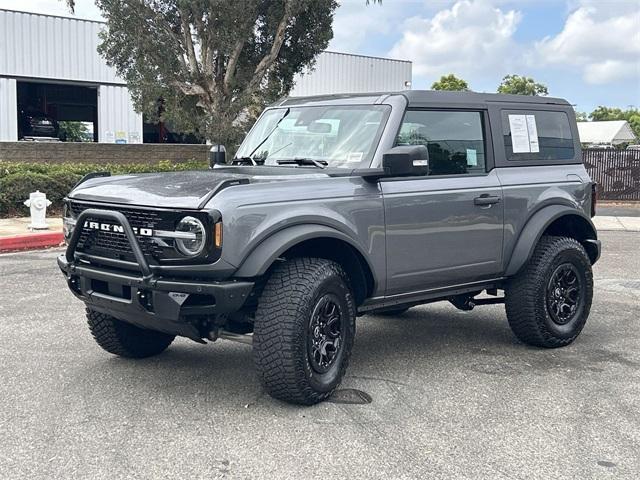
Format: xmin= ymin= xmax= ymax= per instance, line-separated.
xmin=68 ymin=167 xmax=327 ymax=209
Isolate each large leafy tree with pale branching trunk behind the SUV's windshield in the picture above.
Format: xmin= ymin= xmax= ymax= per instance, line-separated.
xmin=96 ymin=0 xmax=337 ymax=146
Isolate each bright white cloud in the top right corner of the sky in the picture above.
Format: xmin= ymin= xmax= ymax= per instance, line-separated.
xmin=531 ymin=0 xmax=640 ymax=85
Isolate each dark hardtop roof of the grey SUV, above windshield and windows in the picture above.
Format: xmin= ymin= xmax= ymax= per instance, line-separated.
xmin=273 ymin=90 xmax=571 ymax=107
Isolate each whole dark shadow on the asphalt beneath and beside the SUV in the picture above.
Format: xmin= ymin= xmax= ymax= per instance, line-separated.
xmin=67 ymin=305 xmax=629 ymax=408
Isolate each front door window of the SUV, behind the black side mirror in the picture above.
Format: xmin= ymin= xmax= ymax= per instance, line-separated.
xmin=396 ymin=110 xmax=485 ymax=175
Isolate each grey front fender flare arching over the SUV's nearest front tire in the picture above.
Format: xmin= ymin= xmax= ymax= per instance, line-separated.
xmin=234 ymin=224 xmax=375 ymax=278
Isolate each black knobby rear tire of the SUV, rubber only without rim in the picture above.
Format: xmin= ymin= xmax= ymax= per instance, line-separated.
xmin=505 ymin=236 xmax=593 ymax=348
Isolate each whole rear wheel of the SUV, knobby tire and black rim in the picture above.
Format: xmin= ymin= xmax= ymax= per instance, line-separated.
xmin=505 ymin=236 xmax=593 ymax=348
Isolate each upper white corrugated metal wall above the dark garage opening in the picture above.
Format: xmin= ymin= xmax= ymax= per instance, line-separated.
xmin=0 ymin=10 xmax=125 ymax=85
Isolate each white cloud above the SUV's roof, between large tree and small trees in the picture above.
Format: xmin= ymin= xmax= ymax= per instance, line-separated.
xmin=389 ymin=0 xmax=522 ymax=76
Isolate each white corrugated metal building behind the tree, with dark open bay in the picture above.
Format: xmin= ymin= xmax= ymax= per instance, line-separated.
xmin=0 ymin=9 xmax=411 ymax=143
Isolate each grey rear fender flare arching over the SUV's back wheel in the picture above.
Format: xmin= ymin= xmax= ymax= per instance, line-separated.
xmin=505 ymin=205 xmax=597 ymax=277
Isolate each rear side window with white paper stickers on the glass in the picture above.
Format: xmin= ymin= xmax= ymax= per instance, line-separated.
xmin=502 ymin=110 xmax=575 ymax=161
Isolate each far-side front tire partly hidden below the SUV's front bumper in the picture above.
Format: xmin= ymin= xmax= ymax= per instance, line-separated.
xmin=87 ymin=308 xmax=175 ymax=358
